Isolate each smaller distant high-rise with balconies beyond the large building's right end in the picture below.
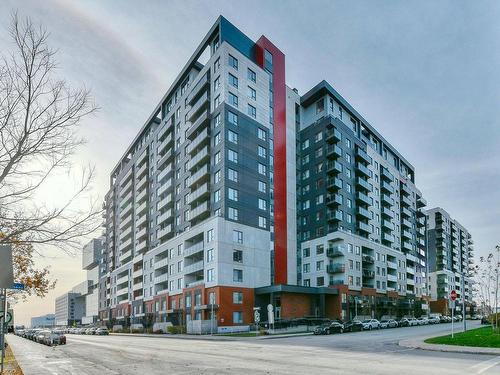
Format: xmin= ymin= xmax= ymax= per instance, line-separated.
xmin=427 ymin=207 xmax=474 ymax=312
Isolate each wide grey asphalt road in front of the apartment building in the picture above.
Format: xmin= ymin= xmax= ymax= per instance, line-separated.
xmin=8 ymin=323 xmax=500 ymax=375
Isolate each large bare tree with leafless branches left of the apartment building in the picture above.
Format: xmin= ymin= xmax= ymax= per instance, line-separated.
xmin=0 ymin=13 xmax=101 ymax=250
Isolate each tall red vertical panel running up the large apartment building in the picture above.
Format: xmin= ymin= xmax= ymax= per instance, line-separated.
xmin=256 ymin=36 xmax=288 ymax=284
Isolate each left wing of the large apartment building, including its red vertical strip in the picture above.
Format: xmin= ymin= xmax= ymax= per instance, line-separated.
xmin=100 ymin=17 xmax=296 ymax=325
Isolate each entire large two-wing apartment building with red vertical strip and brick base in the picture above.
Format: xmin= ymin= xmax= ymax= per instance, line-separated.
xmin=99 ymin=17 xmax=442 ymax=326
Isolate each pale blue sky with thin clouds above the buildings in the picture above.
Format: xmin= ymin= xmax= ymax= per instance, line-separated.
xmin=0 ymin=0 xmax=500 ymax=324
